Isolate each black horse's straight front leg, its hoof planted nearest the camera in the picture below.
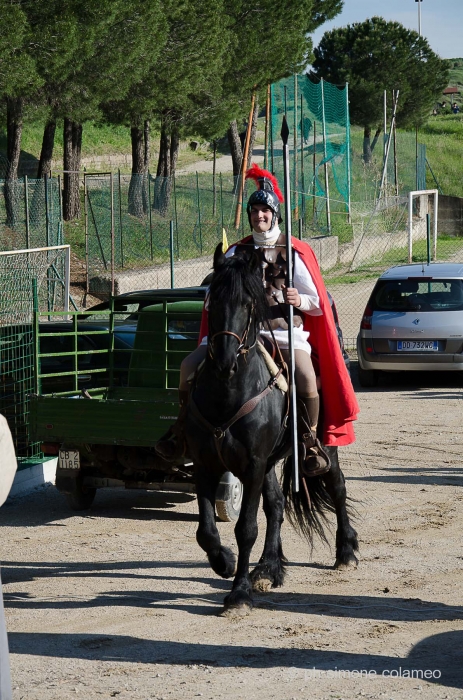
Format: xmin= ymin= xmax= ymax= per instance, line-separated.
xmin=224 ymin=465 xmax=265 ymax=615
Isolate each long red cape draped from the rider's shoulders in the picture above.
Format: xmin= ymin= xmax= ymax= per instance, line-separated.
xmin=199 ymin=236 xmax=360 ymax=447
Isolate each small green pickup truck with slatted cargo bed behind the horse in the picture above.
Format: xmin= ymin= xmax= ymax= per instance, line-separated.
xmin=30 ymin=288 xmax=242 ymax=521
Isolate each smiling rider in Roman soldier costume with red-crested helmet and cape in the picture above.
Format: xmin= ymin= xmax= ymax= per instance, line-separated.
xmin=156 ymin=165 xmax=359 ymax=476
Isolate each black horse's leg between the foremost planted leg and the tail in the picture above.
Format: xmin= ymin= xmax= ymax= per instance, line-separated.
xmin=251 ymin=467 xmax=286 ymax=593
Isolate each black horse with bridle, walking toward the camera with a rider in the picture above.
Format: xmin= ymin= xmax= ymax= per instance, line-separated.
xmin=185 ymin=245 xmax=358 ymax=614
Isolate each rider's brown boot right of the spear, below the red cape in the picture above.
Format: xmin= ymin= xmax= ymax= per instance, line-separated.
xmin=298 ymin=394 xmax=331 ymax=477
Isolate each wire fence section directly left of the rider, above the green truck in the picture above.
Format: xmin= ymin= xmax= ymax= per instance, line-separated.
xmin=85 ymin=173 xmax=249 ymax=296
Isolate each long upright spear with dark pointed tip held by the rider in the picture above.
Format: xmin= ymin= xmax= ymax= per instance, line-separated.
xmin=281 ymin=115 xmax=299 ymax=493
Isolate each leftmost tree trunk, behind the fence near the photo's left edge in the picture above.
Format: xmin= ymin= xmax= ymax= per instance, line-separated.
xmin=4 ymin=97 xmax=23 ymax=226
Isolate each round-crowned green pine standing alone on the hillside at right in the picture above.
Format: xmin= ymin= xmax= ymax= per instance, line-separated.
xmin=311 ymin=17 xmax=448 ymax=162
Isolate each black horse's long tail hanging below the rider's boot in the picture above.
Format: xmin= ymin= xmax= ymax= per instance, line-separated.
xmin=282 ymin=448 xmax=336 ymax=546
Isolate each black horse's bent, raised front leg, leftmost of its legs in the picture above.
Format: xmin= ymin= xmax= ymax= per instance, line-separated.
xmin=195 ymin=466 xmax=236 ymax=578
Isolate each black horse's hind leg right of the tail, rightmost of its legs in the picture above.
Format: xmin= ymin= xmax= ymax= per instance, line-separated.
xmin=321 ymin=447 xmax=358 ymax=569
